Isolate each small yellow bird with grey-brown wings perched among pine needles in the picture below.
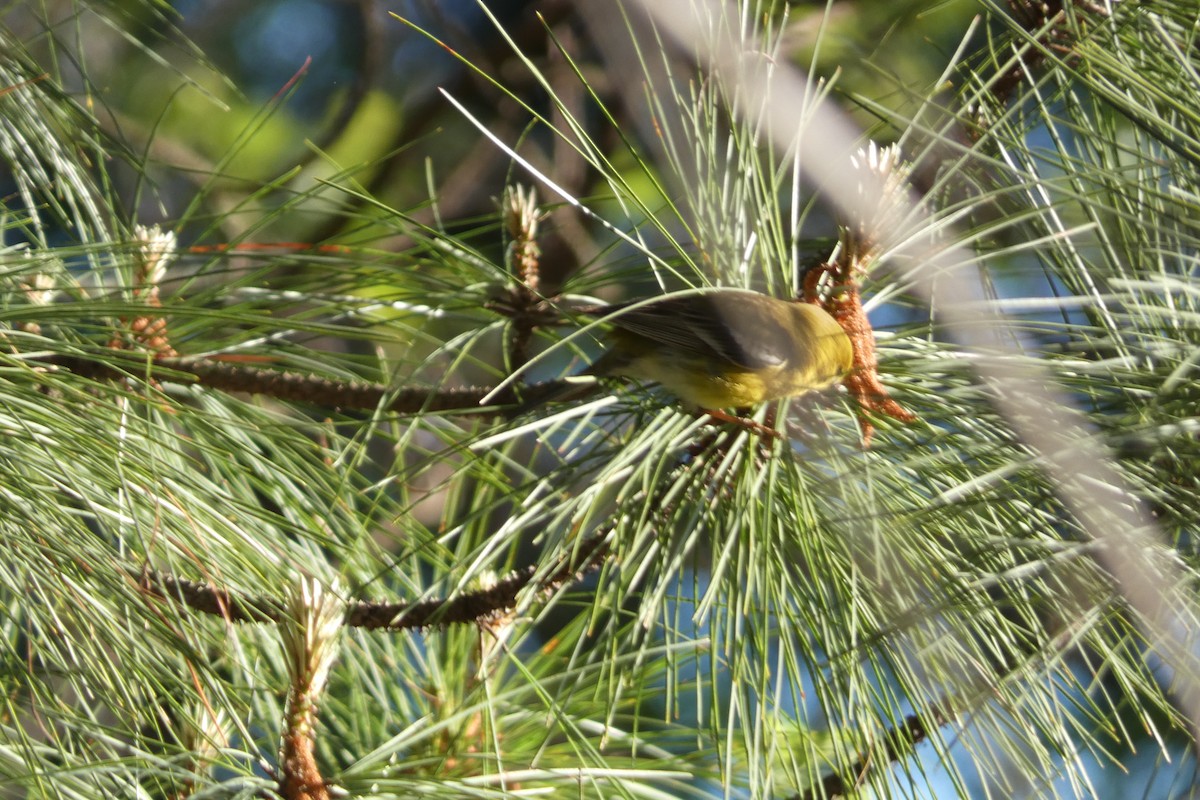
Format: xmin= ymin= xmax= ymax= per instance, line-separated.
xmin=535 ymin=289 xmax=853 ymax=409
